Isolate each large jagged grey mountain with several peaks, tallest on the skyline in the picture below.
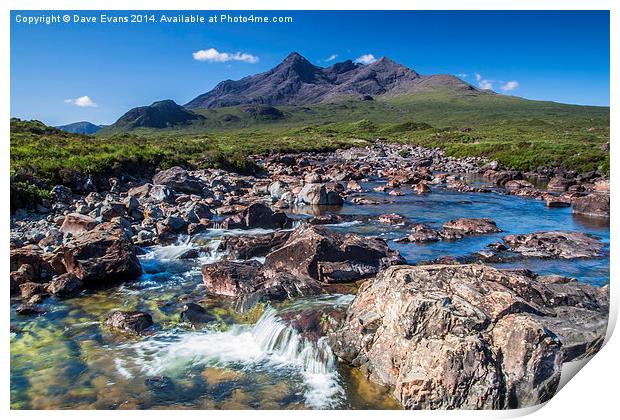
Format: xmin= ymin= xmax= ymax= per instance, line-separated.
xmin=185 ymin=52 xmax=482 ymax=109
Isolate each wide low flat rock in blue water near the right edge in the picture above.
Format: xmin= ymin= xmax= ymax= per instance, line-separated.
xmin=504 ymin=231 xmax=603 ymax=259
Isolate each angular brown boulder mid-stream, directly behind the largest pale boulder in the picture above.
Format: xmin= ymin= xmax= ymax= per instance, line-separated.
xmin=265 ymin=226 xmax=404 ymax=283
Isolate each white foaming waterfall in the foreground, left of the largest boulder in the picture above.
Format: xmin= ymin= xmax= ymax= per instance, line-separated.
xmin=117 ymin=308 xmax=344 ymax=409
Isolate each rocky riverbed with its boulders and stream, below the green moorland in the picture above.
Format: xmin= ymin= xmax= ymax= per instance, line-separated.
xmin=10 ymin=143 xmax=609 ymax=409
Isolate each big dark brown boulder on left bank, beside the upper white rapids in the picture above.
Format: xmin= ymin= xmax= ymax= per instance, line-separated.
xmin=62 ymin=222 xmax=142 ymax=287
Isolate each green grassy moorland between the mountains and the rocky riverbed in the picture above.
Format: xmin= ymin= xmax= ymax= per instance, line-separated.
xmin=11 ymin=92 xmax=609 ymax=210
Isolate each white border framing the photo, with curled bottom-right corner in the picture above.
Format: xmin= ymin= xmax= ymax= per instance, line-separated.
xmin=0 ymin=0 xmax=620 ymax=420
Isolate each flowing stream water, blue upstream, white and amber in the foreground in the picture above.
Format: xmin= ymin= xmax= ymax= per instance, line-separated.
xmin=11 ymin=180 xmax=609 ymax=409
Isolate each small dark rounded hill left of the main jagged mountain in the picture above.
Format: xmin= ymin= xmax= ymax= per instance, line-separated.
xmin=110 ymin=99 xmax=205 ymax=130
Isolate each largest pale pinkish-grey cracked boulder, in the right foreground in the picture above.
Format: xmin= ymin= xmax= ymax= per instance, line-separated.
xmin=329 ymin=265 xmax=609 ymax=409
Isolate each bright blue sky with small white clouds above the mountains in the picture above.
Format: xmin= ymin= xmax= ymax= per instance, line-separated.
xmin=11 ymin=11 xmax=609 ymax=125
